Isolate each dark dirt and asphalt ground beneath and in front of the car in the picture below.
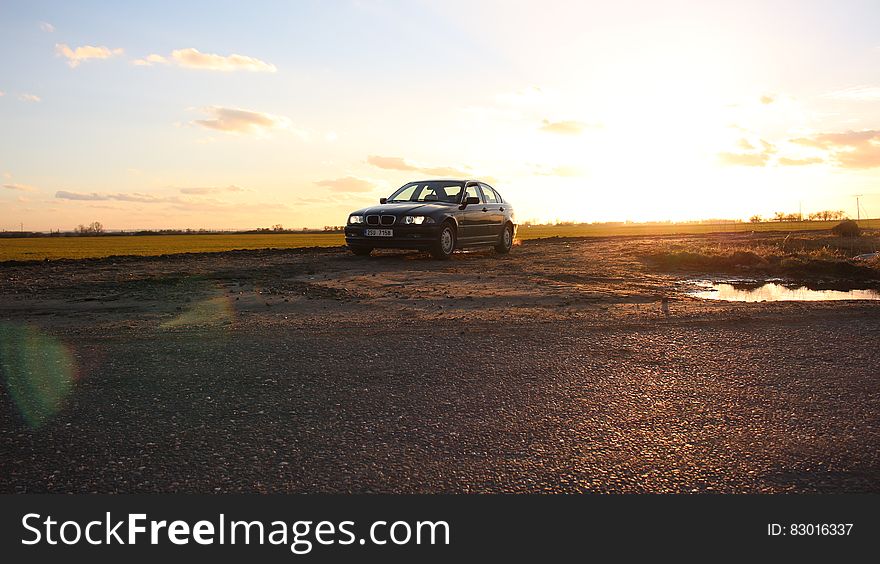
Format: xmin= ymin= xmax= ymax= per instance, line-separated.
xmin=0 ymin=234 xmax=880 ymax=492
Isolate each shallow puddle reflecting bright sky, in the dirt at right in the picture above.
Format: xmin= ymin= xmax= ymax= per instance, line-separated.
xmin=690 ymin=282 xmax=880 ymax=302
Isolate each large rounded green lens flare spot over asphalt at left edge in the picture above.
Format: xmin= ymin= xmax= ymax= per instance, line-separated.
xmin=0 ymin=322 xmax=76 ymax=427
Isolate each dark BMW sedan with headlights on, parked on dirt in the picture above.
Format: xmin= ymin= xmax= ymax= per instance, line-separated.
xmin=345 ymin=180 xmax=516 ymax=259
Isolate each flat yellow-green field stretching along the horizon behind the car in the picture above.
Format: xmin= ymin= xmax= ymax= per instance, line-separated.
xmin=0 ymin=219 xmax=880 ymax=262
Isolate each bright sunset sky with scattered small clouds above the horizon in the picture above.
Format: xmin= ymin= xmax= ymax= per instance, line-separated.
xmin=0 ymin=0 xmax=880 ymax=231
